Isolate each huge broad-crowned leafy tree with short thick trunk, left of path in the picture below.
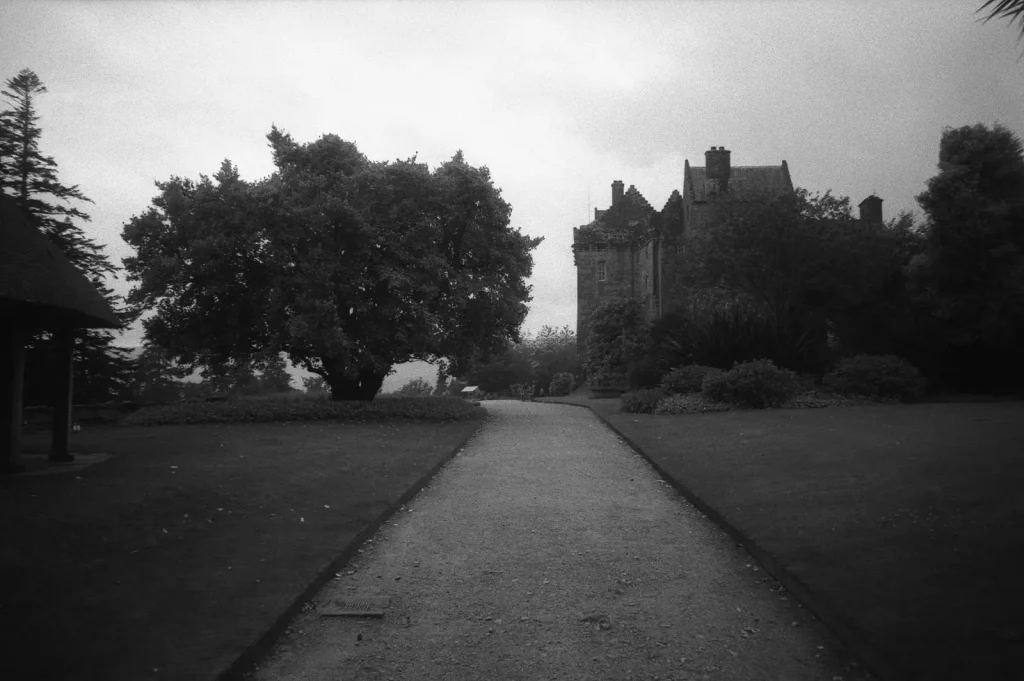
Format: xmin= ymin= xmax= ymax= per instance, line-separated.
xmin=123 ymin=127 xmax=541 ymax=399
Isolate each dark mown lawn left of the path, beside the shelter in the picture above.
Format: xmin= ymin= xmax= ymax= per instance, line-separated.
xmin=0 ymin=419 xmax=480 ymax=681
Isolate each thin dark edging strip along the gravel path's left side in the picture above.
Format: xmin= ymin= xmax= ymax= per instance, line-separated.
xmin=213 ymin=415 xmax=490 ymax=681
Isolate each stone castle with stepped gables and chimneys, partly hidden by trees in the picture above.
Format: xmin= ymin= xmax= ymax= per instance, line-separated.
xmin=572 ymin=146 xmax=882 ymax=350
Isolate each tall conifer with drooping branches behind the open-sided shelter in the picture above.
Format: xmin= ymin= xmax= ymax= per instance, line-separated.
xmin=0 ymin=69 xmax=137 ymax=402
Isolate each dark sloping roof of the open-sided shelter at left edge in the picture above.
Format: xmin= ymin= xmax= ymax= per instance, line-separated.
xmin=0 ymin=195 xmax=121 ymax=329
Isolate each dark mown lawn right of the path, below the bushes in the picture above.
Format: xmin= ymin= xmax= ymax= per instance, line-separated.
xmin=552 ymin=398 xmax=1024 ymax=681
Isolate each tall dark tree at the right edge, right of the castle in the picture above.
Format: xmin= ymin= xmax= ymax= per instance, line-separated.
xmin=909 ymin=124 xmax=1024 ymax=390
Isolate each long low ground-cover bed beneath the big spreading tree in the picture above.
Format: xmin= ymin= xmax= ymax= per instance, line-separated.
xmin=122 ymin=396 xmax=483 ymax=426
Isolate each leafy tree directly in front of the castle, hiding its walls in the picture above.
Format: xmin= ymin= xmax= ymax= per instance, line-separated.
xmin=680 ymin=188 xmax=852 ymax=370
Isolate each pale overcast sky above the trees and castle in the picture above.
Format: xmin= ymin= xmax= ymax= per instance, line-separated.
xmin=0 ymin=0 xmax=1024 ymax=345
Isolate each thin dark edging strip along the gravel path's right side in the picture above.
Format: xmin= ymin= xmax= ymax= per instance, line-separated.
xmin=547 ymin=401 xmax=905 ymax=681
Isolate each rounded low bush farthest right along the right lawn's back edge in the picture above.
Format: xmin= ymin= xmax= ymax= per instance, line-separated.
xmin=822 ymin=354 xmax=925 ymax=400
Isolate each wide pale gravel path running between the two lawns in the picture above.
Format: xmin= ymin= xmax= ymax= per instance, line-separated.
xmin=252 ymin=401 xmax=868 ymax=681
